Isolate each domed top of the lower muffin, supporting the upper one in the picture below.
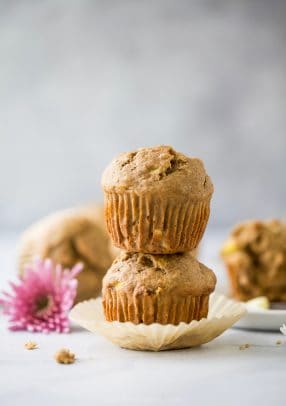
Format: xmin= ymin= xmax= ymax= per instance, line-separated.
xmin=103 ymin=252 xmax=216 ymax=296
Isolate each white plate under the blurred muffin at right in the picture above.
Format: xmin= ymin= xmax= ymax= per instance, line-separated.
xmin=234 ymin=307 xmax=286 ymax=331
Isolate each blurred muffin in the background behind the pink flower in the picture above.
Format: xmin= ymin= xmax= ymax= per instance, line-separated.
xmin=18 ymin=205 xmax=119 ymax=302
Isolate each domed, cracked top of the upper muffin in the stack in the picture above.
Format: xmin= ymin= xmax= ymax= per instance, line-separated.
xmin=102 ymin=145 xmax=213 ymax=199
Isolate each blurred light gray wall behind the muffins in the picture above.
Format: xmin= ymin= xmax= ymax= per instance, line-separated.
xmin=0 ymin=0 xmax=286 ymax=230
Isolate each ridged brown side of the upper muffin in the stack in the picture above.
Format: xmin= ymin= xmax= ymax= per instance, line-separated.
xmin=105 ymin=192 xmax=210 ymax=254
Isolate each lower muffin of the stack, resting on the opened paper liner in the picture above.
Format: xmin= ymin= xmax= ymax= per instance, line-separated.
xmin=102 ymin=253 xmax=216 ymax=325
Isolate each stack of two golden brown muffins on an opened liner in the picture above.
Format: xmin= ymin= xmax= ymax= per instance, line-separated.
xmin=102 ymin=146 xmax=216 ymax=324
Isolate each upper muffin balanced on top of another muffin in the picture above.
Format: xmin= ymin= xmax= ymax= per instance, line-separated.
xmin=102 ymin=146 xmax=213 ymax=254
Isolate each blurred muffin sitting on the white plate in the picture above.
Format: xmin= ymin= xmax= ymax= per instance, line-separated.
xmin=221 ymin=220 xmax=286 ymax=302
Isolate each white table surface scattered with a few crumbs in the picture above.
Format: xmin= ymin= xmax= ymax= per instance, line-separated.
xmin=0 ymin=233 xmax=286 ymax=406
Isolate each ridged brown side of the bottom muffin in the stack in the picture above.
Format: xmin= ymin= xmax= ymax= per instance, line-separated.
xmin=102 ymin=289 xmax=209 ymax=325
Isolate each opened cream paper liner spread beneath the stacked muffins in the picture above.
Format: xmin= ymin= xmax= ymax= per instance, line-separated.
xmin=70 ymin=293 xmax=246 ymax=351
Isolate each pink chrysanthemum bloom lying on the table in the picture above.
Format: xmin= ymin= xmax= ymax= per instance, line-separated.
xmin=0 ymin=259 xmax=82 ymax=333
